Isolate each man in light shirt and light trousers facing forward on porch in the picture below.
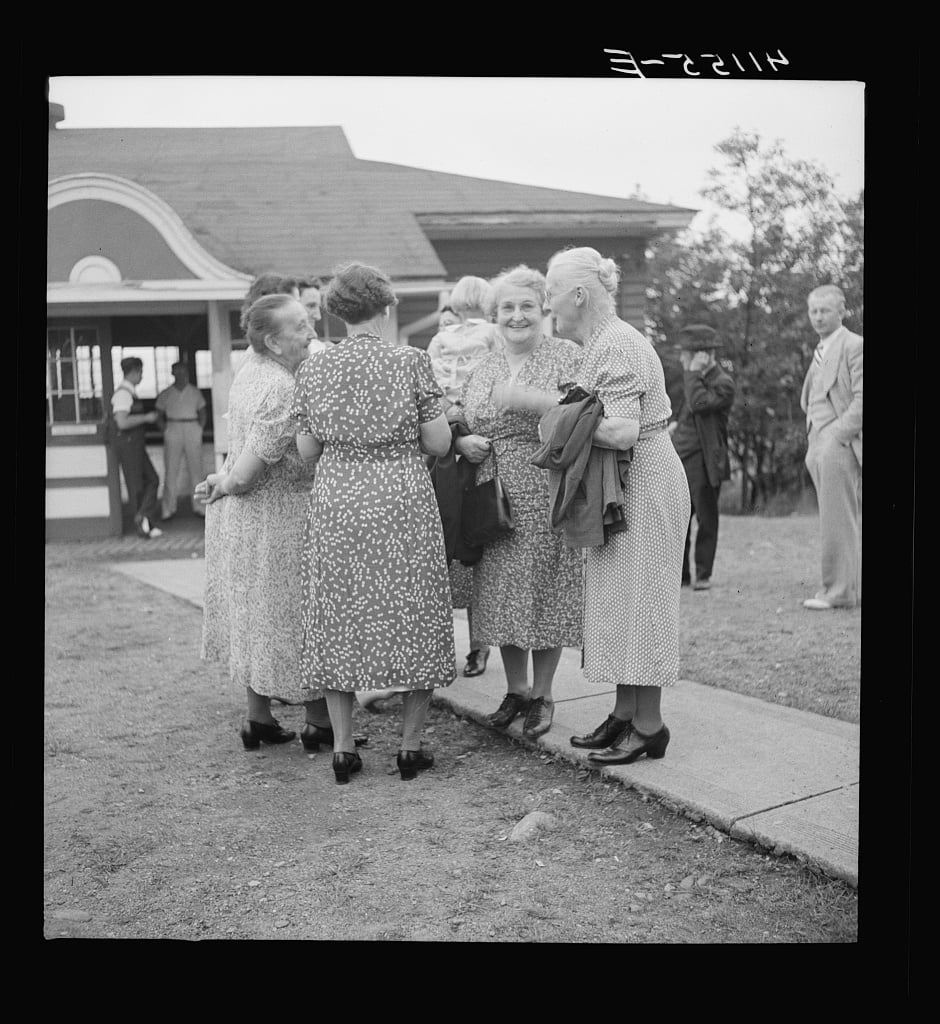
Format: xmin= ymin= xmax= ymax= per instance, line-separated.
xmin=157 ymin=362 xmax=206 ymax=519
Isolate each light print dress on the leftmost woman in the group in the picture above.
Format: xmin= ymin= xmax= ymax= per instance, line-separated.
xmin=202 ymin=352 xmax=313 ymax=703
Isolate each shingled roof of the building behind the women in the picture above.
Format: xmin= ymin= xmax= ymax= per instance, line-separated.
xmin=49 ymin=126 xmax=695 ymax=280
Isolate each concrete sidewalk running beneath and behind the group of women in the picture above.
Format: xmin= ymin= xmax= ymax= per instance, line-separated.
xmin=112 ymin=557 xmax=859 ymax=887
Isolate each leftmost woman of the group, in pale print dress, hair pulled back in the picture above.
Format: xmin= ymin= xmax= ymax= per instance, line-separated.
xmin=194 ymin=294 xmax=333 ymax=751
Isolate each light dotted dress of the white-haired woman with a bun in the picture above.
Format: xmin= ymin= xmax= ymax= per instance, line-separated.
xmin=578 ymin=316 xmax=691 ymax=686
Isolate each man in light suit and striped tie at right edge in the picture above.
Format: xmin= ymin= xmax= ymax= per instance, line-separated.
xmin=800 ymin=285 xmax=862 ymax=611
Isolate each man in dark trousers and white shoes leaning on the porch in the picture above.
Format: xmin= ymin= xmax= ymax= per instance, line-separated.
xmin=111 ymin=355 xmax=163 ymax=539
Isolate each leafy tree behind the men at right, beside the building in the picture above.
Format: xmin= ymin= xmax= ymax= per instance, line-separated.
xmin=647 ymin=129 xmax=863 ymax=512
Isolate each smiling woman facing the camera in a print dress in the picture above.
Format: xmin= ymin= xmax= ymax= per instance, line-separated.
xmin=455 ymin=266 xmax=582 ymax=739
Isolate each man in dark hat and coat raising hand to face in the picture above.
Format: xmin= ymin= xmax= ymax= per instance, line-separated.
xmin=670 ymin=324 xmax=734 ymax=590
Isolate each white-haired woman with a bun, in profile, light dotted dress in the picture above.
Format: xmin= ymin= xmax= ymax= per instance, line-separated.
xmin=547 ymin=247 xmax=691 ymax=765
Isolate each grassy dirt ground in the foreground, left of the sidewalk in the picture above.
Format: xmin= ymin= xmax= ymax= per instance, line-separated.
xmin=44 ymin=545 xmax=858 ymax=943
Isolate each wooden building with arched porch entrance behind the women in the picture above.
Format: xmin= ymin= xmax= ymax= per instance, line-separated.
xmin=46 ymin=103 xmax=696 ymax=540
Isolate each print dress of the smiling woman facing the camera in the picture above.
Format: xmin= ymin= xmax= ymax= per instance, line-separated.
xmin=461 ymin=338 xmax=582 ymax=650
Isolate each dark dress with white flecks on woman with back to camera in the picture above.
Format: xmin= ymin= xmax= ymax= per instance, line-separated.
xmin=293 ymin=334 xmax=457 ymax=699
